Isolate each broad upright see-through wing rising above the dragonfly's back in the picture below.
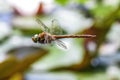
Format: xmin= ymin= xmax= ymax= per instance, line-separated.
xmin=50 ymin=19 xmax=63 ymax=35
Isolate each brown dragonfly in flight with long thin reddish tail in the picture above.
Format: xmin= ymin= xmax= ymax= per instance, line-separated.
xmin=32 ymin=17 xmax=96 ymax=49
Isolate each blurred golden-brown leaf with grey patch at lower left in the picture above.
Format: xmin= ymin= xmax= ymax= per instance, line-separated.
xmin=0 ymin=48 xmax=47 ymax=80
